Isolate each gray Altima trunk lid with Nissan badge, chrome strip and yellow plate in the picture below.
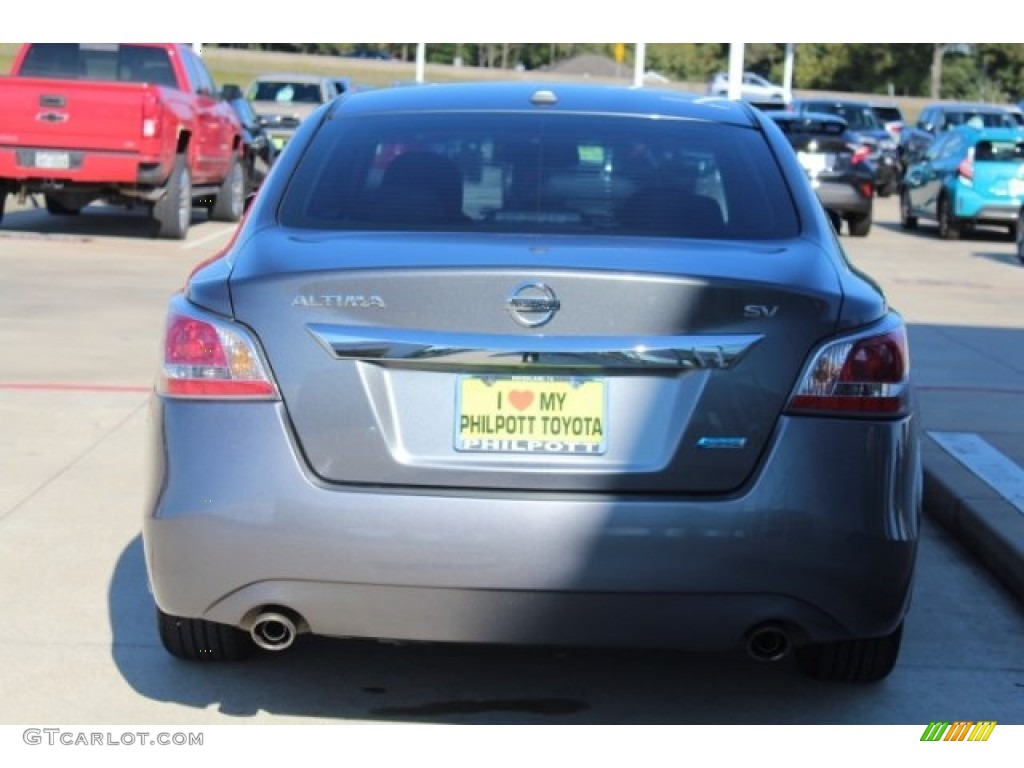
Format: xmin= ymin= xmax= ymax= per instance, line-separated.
xmin=231 ymin=233 xmax=841 ymax=494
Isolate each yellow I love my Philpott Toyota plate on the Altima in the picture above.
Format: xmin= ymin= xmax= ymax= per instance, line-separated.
xmin=455 ymin=376 xmax=607 ymax=456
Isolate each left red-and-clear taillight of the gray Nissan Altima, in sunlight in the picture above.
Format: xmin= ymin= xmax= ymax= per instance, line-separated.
xmin=157 ymin=310 xmax=279 ymax=400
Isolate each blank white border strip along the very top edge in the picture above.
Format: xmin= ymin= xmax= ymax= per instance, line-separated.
xmin=0 ymin=0 xmax=1020 ymax=43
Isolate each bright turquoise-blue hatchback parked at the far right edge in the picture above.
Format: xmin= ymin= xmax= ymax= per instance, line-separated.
xmin=900 ymin=125 xmax=1024 ymax=240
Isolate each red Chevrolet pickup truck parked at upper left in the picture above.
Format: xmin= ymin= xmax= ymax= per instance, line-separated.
xmin=0 ymin=43 xmax=246 ymax=240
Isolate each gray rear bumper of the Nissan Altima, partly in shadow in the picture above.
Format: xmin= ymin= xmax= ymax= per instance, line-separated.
xmin=143 ymin=400 xmax=921 ymax=649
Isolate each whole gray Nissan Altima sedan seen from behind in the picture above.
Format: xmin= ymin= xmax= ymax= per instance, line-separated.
xmin=143 ymin=82 xmax=922 ymax=682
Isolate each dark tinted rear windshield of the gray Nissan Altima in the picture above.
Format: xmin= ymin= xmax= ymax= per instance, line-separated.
xmin=280 ymin=113 xmax=799 ymax=240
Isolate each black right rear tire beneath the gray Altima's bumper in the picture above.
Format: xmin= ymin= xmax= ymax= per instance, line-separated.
xmin=795 ymin=622 xmax=903 ymax=683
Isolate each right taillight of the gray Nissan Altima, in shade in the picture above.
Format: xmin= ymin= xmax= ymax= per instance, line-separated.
xmin=787 ymin=325 xmax=910 ymax=416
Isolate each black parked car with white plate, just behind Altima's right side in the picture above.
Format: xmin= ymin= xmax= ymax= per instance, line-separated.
xmin=769 ymin=112 xmax=876 ymax=238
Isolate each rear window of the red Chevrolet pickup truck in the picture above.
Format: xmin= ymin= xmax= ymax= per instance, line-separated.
xmin=18 ymin=43 xmax=177 ymax=88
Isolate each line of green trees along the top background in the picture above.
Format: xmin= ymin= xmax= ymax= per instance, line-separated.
xmin=209 ymin=43 xmax=1024 ymax=101
